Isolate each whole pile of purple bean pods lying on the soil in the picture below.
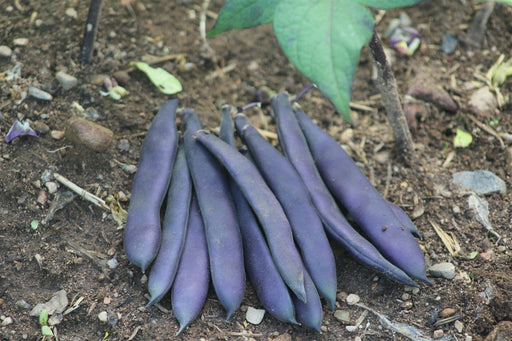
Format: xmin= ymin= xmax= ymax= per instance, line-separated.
xmin=124 ymin=92 xmax=430 ymax=333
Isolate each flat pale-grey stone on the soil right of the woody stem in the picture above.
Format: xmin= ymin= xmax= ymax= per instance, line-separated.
xmin=452 ymin=170 xmax=507 ymax=194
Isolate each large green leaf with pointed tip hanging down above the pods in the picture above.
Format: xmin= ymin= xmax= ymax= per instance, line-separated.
xmin=273 ymin=0 xmax=374 ymax=121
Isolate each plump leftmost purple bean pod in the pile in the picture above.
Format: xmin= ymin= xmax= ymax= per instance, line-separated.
xmin=123 ymin=100 xmax=178 ymax=272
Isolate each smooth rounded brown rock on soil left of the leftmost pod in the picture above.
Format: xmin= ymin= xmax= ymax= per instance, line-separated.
xmin=66 ymin=117 xmax=114 ymax=152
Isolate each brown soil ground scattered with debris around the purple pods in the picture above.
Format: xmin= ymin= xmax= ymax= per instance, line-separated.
xmin=0 ymin=0 xmax=512 ymax=340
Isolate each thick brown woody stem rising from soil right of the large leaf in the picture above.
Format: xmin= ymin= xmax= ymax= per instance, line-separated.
xmin=369 ymin=29 xmax=416 ymax=160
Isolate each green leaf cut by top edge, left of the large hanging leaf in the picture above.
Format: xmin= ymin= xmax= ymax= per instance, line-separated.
xmin=207 ymin=0 xmax=279 ymax=38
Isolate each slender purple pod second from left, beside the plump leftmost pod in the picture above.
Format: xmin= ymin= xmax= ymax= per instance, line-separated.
xmin=148 ymin=145 xmax=192 ymax=306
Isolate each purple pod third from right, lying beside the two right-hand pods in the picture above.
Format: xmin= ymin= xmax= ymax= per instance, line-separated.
xmin=235 ymin=115 xmax=337 ymax=309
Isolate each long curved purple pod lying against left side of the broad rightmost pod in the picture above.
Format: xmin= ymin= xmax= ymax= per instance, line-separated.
xmin=271 ymin=92 xmax=417 ymax=286
